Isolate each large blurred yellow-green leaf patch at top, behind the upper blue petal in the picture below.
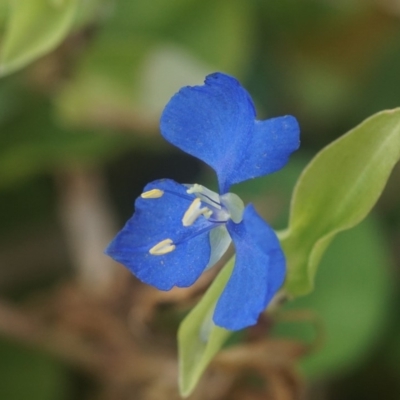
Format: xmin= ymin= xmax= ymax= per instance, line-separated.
xmin=57 ymin=0 xmax=252 ymax=132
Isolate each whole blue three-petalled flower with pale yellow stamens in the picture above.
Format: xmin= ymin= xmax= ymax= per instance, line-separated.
xmin=106 ymin=73 xmax=299 ymax=330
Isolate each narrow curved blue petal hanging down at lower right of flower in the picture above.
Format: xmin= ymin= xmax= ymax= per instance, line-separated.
xmin=213 ymin=205 xmax=285 ymax=330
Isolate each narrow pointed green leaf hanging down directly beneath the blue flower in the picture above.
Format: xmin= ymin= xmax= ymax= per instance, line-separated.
xmin=178 ymin=259 xmax=234 ymax=397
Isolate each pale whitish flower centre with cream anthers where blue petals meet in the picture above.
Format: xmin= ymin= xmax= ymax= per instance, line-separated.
xmin=182 ymin=184 xmax=244 ymax=226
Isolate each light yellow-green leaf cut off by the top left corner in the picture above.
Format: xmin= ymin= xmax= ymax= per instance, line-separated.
xmin=0 ymin=0 xmax=78 ymax=76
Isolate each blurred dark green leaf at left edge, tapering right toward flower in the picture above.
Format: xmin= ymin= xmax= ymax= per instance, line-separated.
xmin=0 ymin=99 xmax=126 ymax=186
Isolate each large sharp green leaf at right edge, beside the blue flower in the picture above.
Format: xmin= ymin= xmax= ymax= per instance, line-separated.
xmin=281 ymin=109 xmax=400 ymax=296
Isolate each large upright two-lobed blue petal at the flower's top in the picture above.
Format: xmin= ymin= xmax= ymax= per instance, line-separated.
xmin=160 ymin=73 xmax=299 ymax=194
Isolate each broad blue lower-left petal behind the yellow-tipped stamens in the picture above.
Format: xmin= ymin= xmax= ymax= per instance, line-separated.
xmin=106 ymin=179 xmax=213 ymax=290
